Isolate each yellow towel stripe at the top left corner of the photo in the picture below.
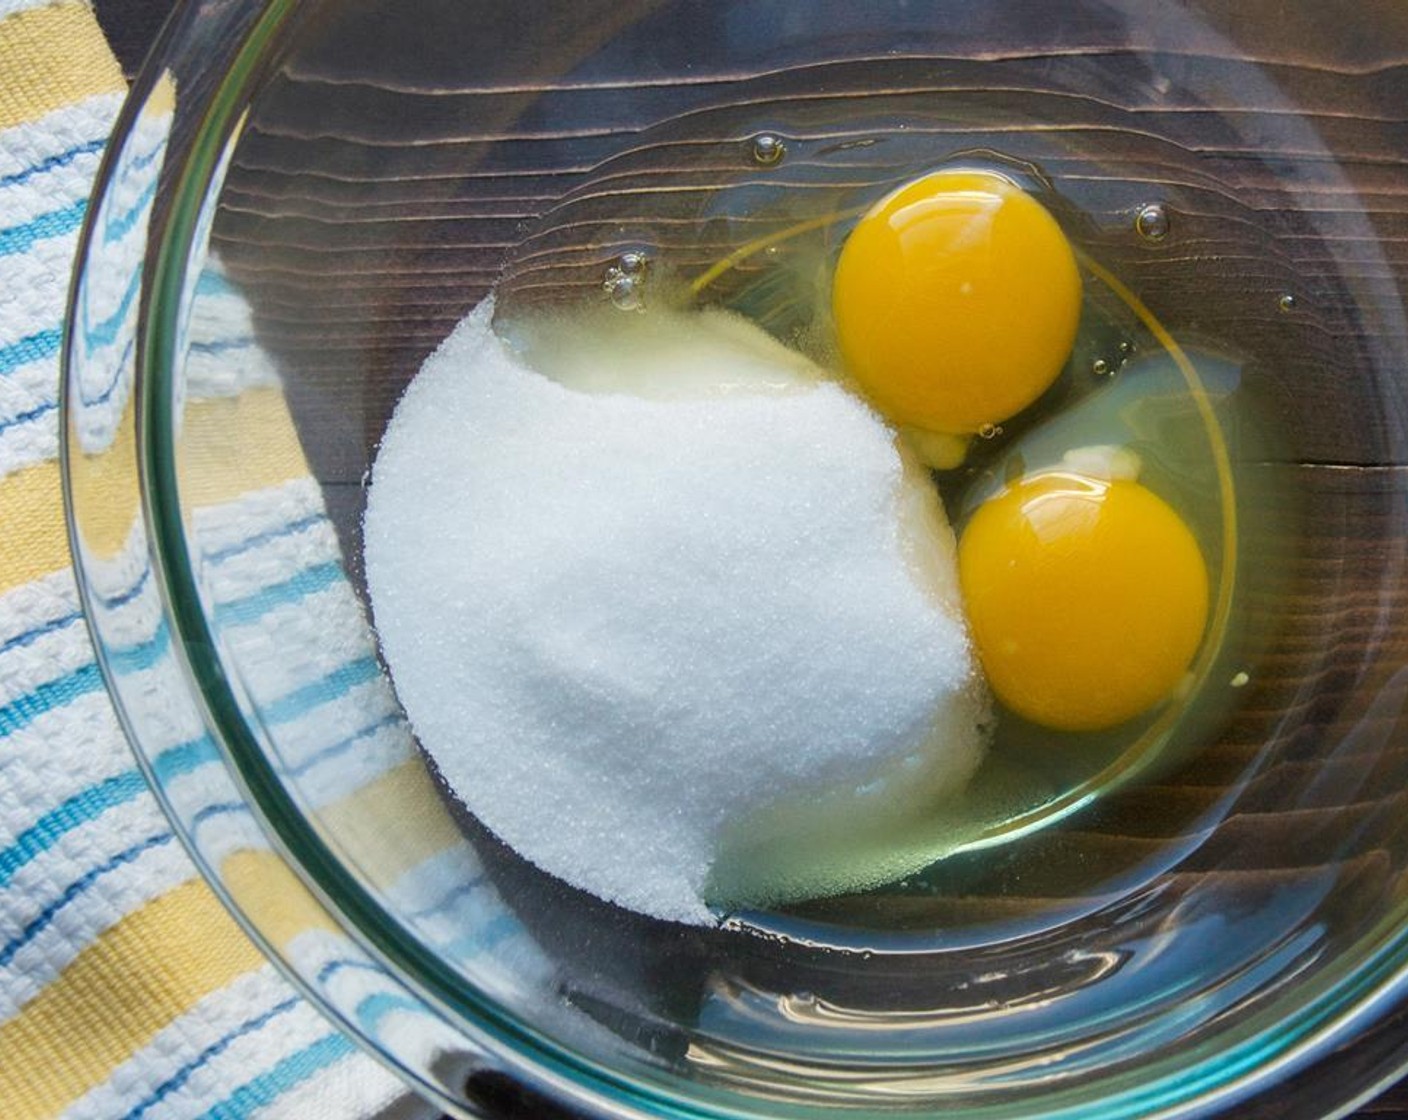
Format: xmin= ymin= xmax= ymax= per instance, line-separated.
xmin=0 ymin=3 xmax=127 ymax=128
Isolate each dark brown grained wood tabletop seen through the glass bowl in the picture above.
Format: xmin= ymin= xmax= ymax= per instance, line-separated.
xmin=100 ymin=0 xmax=1408 ymax=1117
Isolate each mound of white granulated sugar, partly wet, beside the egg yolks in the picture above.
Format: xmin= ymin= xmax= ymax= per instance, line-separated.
xmin=365 ymin=301 xmax=986 ymax=924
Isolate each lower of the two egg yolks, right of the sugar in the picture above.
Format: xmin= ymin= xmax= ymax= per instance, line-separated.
xmin=959 ymin=472 xmax=1208 ymax=731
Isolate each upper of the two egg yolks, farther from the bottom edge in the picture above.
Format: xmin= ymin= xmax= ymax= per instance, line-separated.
xmin=832 ymin=170 xmax=1081 ymax=435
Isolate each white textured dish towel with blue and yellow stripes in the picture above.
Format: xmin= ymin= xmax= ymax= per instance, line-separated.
xmin=0 ymin=0 xmax=472 ymax=1120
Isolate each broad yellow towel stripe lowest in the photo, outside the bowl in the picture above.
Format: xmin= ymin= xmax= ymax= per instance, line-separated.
xmin=0 ymin=879 xmax=263 ymax=1120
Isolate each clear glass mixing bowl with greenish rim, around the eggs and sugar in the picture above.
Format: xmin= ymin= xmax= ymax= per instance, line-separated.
xmin=65 ymin=0 xmax=1408 ymax=1120
